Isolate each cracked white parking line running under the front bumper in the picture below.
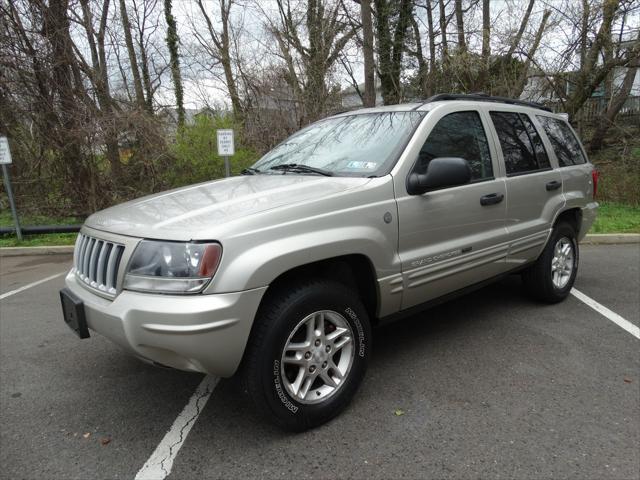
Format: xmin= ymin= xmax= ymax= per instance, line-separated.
xmin=135 ymin=375 xmax=219 ymax=480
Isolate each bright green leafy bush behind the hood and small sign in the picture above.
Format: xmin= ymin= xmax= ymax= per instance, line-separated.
xmin=166 ymin=115 xmax=258 ymax=187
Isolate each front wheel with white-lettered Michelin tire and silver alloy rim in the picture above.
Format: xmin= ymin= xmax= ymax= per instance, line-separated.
xmin=244 ymin=280 xmax=371 ymax=431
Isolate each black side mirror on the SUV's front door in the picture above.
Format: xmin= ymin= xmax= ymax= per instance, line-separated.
xmin=407 ymin=157 xmax=471 ymax=195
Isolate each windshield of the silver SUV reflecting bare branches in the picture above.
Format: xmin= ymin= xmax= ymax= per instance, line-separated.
xmin=252 ymin=112 xmax=425 ymax=177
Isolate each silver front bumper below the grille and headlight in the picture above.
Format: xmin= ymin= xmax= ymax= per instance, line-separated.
xmin=65 ymin=273 xmax=267 ymax=377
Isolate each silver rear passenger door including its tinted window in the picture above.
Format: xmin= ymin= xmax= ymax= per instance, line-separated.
xmin=489 ymin=108 xmax=564 ymax=268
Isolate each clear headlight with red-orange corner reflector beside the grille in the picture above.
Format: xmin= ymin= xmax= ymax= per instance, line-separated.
xmin=124 ymin=240 xmax=222 ymax=293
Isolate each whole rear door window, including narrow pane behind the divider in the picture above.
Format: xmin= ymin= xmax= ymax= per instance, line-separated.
xmin=491 ymin=112 xmax=549 ymax=175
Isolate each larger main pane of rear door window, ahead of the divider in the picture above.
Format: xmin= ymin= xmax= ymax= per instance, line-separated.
xmin=491 ymin=112 xmax=538 ymax=175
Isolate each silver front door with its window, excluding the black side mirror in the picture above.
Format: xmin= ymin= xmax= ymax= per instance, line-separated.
xmin=395 ymin=106 xmax=508 ymax=309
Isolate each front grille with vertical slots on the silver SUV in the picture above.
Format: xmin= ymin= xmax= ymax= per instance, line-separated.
xmin=73 ymin=233 xmax=124 ymax=296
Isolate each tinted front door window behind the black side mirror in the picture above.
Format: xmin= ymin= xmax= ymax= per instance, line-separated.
xmin=415 ymin=112 xmax=493 ymax=180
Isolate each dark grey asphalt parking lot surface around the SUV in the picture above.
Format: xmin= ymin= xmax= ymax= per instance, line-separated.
xmin=0 ymin=245 xmax=640 ymax=479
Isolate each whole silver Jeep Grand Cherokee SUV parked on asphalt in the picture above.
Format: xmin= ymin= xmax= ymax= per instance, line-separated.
xmin=61 ymin=95 xmax=597 ymax=430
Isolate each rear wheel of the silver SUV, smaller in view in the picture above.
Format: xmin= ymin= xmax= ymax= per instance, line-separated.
xmin=522 ymin=222 xmax=579 ymax=303
